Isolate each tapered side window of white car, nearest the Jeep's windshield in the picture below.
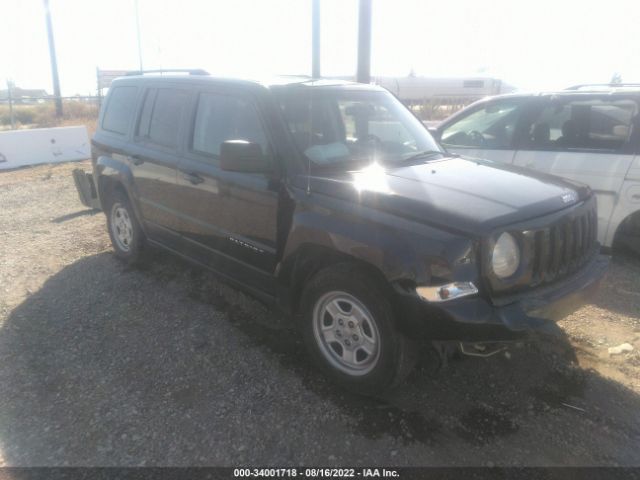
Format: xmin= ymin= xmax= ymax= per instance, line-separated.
xmin=441 ymin=100 xmax=523 ymax=149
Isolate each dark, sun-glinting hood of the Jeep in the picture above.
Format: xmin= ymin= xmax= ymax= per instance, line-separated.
xmin=300 ymin=158 xmax=591 ymax=234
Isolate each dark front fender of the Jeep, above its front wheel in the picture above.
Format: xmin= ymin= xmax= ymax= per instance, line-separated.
xmin=283 ymin=195 xmax=478 ymax=285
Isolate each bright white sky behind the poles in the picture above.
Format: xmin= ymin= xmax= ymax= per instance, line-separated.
xmin=0 ymin=0 xmax=640 ymax=95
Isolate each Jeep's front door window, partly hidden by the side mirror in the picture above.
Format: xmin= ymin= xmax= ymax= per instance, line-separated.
xmin=191 ymin=93 xmax=267 ymax=158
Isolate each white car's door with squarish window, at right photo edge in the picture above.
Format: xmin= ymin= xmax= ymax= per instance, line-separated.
xmin=514 ymin=94 xmax=638 ymax=246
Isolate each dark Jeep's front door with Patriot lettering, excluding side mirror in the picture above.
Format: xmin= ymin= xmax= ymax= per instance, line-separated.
xmin=177 ymin=88 xmax=280 ymax=291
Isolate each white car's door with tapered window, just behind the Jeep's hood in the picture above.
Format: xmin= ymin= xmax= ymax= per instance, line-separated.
xmin=438 ymin=98 xmax=532 ymax=163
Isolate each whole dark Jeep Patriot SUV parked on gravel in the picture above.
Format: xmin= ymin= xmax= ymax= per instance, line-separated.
xmin=74 ymin=72 xmax=608 ymax=392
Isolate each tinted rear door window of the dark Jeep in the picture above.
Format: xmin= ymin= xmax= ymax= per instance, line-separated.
xmin=136 ymin=88 xmax=187 ymax=148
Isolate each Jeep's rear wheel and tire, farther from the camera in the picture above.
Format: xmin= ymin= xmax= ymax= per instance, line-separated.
xmin=105 ymin=189 xmax=144 ymax=264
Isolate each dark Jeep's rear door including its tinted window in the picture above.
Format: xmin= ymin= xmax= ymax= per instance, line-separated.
xmin=128 ymin=83 xmax=190 ymax=248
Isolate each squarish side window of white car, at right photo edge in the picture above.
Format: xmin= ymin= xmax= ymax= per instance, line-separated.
xmin=526 ymin=98 xmax=638 ymax=151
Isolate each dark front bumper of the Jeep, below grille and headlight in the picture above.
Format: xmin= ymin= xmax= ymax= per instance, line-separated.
xmin=404 ymin=255 xmax=609 ymax=341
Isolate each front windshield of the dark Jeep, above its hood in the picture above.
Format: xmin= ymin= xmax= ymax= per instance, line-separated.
xmin=276 ymin=87 xmax=443 ymax=168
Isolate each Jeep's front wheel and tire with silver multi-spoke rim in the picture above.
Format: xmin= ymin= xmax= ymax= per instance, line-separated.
xmin=301 ymin=264 xmax=417 ymax=395
